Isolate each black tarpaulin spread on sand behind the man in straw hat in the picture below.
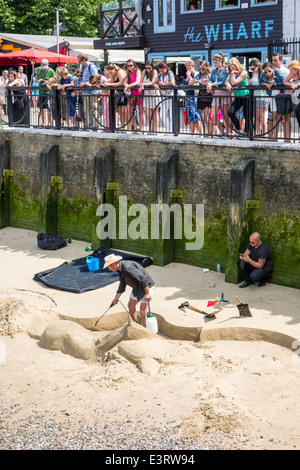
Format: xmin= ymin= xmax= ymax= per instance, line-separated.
xmin=33 ymin=248 xmax=153 ymax=293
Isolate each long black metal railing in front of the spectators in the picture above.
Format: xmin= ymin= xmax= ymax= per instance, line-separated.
xmin=0 ymin=86 xmax=300 ymax=142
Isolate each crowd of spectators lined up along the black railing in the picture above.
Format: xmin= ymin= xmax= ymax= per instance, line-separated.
xmin=0 ymin=53 xmax=300 ymax=141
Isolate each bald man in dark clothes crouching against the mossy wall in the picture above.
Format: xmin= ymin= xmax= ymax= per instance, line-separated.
xmin=237 ymin=232 xmax=273 ymax=288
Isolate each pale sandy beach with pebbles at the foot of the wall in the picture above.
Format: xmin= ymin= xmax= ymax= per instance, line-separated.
xmin=0 ymin=228 xmax=300 ymax=450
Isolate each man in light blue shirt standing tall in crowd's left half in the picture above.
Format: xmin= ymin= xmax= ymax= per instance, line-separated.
xmin=77 ymin=54 xmax=98 ymax=128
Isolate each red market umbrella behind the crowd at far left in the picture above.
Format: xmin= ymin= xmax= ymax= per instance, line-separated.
xmin=0 ymin=48 xmax=78 ymax=65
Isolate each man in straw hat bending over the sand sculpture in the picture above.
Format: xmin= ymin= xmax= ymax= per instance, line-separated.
xmin=104 ymin=254 xmax=154 ymax=327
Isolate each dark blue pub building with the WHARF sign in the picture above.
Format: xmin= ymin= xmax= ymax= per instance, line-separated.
xmin=94 ymin=0 xmax=298 ymax=74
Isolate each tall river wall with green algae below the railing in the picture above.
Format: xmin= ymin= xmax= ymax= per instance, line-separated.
xmin=0 ymin=129 xmax=300 ymax=288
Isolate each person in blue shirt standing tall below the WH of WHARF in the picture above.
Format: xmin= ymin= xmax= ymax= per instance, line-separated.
xmin=206 ymin=52 xmax=232 ymax=134
